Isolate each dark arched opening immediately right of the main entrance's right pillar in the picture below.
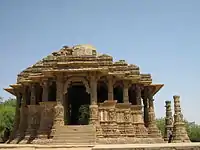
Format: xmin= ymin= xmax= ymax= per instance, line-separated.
xmin=97 ymin=81 xmax=108 ymax=103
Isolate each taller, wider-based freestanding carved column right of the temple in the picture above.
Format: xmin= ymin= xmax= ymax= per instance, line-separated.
xmin=172 ymin=95 xmax=190 ymax=143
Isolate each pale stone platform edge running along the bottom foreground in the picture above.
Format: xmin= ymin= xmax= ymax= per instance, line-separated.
xmin=0 ymin=143 xmax=200 ymax=150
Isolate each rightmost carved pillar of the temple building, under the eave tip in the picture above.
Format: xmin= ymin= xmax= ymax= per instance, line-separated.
xmin=148 ymin=87 xmax=162 ymax=140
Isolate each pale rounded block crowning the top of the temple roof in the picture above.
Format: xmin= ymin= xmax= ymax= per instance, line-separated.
xmin=72 ymin=44 xmax=98 ymax=56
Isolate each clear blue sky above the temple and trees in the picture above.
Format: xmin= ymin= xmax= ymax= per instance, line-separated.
xmin=0 ymin=0 xmax=200 ymax=123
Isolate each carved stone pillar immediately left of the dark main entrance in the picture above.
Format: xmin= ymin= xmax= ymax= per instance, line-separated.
xmin=51 ymin=74 xmax=64 ymax=136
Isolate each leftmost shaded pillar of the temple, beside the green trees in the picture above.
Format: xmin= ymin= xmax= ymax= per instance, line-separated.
xmin=9 ymin=91 xmax=22 ymax=142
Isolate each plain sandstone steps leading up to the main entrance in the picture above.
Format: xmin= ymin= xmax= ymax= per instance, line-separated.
xmin=53 ymin=125 xmax=95 ymax=145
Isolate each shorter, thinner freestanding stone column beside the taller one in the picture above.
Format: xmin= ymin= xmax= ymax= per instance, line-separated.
xmin=164 ymin=101 xmax=173 ymax=141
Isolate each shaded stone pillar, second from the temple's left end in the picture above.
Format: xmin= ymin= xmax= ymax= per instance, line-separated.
xmin=19 ymin=87 xmax=28 ymax=138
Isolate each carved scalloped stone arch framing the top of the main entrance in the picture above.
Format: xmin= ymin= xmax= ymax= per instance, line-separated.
xmin=64 ymin=77 xmax=90 ymax=94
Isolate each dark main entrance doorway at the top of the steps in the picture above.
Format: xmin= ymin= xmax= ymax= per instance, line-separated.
xmin=64 ymin=83 xmax=90 ymax=125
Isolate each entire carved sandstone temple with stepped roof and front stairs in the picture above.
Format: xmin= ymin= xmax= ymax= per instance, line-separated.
xmin=5 ymin=45 xmax=164 ymax=144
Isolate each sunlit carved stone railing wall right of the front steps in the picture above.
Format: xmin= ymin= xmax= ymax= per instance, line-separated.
xmin=99 ymin=100 xmax=147 ymax=137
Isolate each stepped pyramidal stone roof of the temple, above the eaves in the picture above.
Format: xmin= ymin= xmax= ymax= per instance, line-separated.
xmin=17 ymin=44 xmax=152 ymax=84
